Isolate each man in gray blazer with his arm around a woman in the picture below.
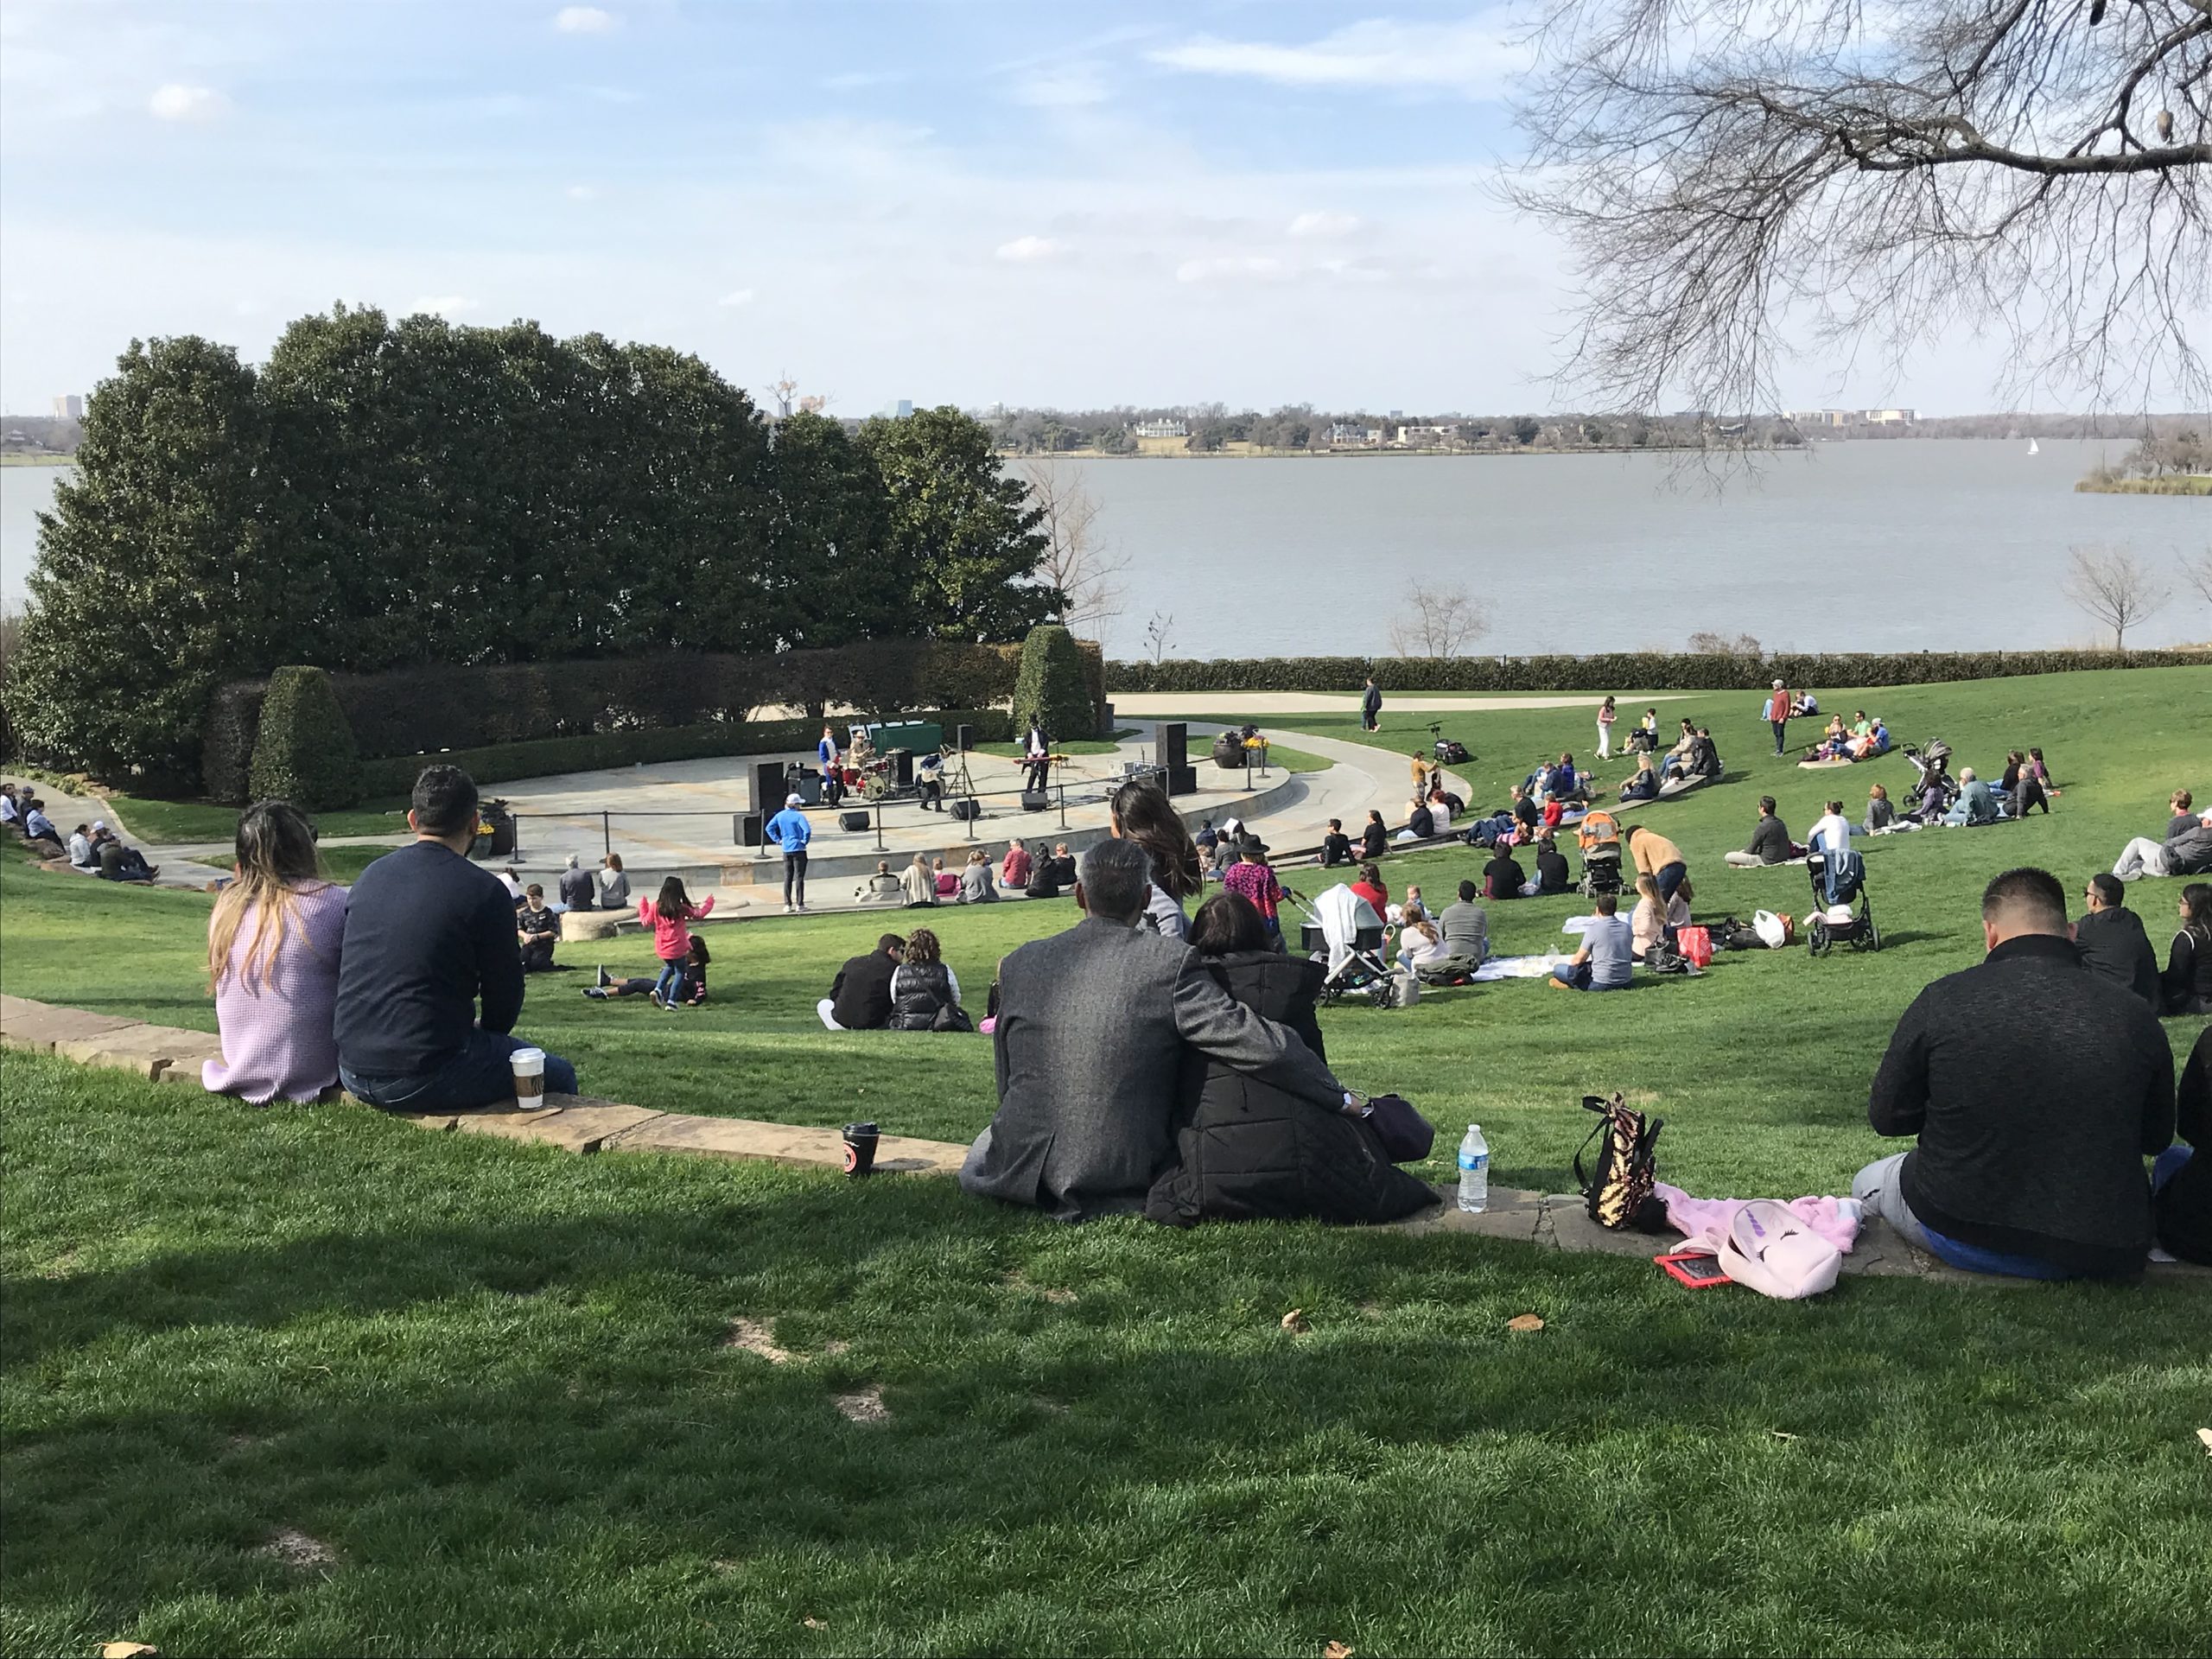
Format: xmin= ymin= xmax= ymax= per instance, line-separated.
xmin=960 ymin=841 xmax=1358 ymax=1221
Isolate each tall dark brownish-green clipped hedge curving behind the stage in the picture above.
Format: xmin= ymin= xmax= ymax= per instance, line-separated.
xmin=201 ymin=639 xmax=1103 ymax=803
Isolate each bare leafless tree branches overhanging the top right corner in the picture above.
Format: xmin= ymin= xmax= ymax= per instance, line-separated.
xmin=1509 ymin=0 xmax=2212 ymax=414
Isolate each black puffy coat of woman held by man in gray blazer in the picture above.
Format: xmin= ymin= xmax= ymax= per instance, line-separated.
xmin=1144 ymin=951 xmax=1435 ymax=1228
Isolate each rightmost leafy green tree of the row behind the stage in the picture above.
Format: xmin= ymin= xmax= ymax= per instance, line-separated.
xmin=861 ymin=404 xmax=1059 ymax=644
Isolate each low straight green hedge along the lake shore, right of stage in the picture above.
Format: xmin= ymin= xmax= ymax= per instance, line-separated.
xmin=1106 ymin=651 xmax=2212 ymax=692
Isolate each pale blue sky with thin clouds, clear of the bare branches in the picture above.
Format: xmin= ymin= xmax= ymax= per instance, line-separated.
xmin=0 ymin=0 xmax=2025 ymax=414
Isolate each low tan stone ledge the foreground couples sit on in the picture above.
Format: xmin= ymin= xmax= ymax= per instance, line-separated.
xmin=0 ymin=995 xmax=2212 ymax=1294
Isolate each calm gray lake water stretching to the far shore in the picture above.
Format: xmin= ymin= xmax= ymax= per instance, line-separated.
xmin=0 ymin=438 xmax=2212 ymax=657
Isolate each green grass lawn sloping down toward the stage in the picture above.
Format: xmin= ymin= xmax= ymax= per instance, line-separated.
xmin=0 ymin=671 xmax=2212 ymax=1655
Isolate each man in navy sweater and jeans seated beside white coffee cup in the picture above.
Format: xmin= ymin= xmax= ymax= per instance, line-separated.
xmin=336 ymin=766 xmax=575 ymax=1113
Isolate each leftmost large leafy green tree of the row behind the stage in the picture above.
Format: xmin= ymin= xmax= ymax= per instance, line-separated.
xmin=9 ymin=334 xmax=301 ymax=783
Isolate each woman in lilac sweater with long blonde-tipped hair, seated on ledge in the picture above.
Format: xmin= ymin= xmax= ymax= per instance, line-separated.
xmin=199 ymin=801 xmax=347 ymax=1106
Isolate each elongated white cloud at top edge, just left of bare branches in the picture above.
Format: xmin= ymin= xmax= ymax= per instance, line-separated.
xmin=1150 ymin=17 xmax=1526 ymax=98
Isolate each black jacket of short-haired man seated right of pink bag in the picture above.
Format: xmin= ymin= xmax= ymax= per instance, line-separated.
xmin=1867 ymin=933 xmax=2174 ymax=1279
